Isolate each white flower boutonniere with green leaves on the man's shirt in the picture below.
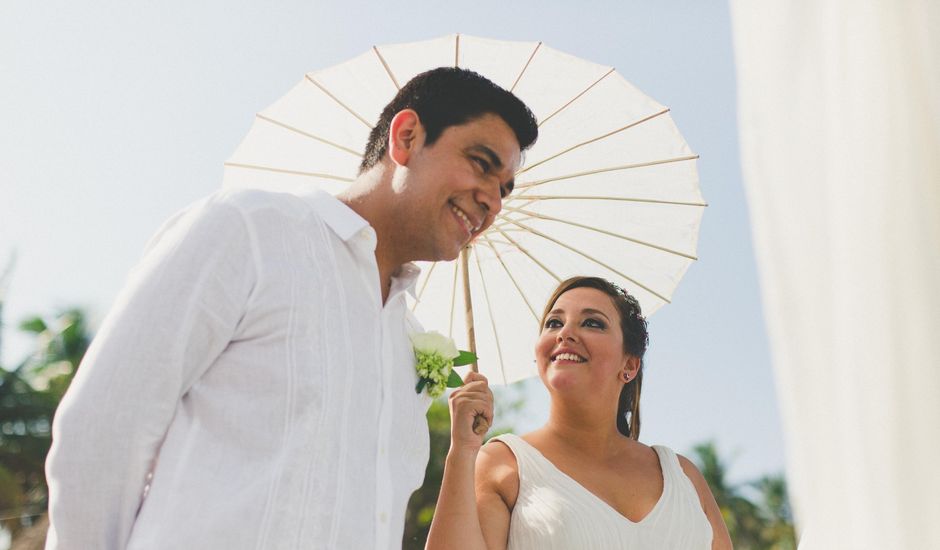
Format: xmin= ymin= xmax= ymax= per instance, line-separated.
xmin=411 ymin=330 xmax=477 ymax=398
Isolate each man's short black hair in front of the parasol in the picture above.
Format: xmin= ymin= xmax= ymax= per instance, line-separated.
xmin=359 ymin=67 xmax=539 ymax=174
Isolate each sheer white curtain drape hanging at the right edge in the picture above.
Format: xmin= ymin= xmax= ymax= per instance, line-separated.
xmin=731 ymin=0 xmax=940 ymax=550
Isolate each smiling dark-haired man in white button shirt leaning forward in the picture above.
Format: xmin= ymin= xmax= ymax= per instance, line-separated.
xmin=47 ymin=69 xmax=537 ymax=550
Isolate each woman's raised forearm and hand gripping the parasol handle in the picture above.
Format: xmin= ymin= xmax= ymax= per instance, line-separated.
xmin=425 ymin=373 xmax=493 ymax=550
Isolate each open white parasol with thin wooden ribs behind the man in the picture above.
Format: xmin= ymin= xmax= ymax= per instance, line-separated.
xmin=225 ymin=35 xmax=705 ymax=384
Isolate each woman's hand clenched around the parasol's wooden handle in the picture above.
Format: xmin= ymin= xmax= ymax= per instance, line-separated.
xmin=450 ymin=372 xmax=493 ymax=453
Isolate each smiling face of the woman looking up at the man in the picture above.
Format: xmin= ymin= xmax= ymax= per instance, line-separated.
xmin=535 ymin=287 xmax=635 ymax=393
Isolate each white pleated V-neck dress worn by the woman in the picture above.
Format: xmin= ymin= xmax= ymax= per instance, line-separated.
xmin=493 ymin=434 xmax=712 ymax=550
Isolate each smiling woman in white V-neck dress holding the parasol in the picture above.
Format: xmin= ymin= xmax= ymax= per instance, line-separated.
xmin=427 ymin=277 xmax=731 ymax=550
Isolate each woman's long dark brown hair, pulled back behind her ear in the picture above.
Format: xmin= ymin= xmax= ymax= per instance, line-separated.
xmin=539 ymin=277 xmax=649 ymax=440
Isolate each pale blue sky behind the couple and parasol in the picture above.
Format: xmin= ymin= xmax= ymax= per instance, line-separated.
xmin=0 ymin=0 xmax=784 ymax=480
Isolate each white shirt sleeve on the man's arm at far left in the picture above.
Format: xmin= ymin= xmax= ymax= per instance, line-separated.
xmin=46 ymin=195 xmax=259 ymax=550
